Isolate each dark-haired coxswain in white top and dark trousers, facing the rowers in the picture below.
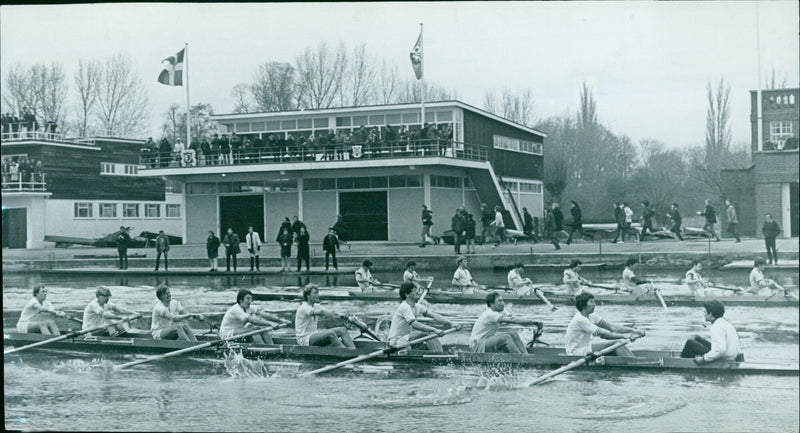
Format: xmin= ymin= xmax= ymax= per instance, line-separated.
xmin=681 ymin=300 xmax=743 ymax=364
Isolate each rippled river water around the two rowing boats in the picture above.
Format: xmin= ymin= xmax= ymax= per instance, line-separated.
xmin=3 ymin=271 xmax=800 ymax=432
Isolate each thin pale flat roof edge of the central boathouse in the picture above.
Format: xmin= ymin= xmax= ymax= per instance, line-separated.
xmin=211 ymin=100 xmax=547 ymax=137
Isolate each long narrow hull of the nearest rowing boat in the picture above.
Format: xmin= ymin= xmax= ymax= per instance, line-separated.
xmin=3 ymin=332 xmax=800 ymax=376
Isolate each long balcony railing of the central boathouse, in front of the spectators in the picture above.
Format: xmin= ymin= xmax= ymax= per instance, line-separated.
xmin=140 ymin=139 xmax=489 ymax=168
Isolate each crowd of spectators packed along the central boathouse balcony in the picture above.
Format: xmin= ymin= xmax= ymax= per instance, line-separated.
xmin=142 ymin=123 xmax=453 ymax=167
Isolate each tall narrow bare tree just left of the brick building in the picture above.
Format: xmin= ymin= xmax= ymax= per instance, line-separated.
xmin=706 ymin=78 xmax=731 ymax=165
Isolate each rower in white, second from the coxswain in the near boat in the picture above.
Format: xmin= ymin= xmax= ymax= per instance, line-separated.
xmin=469 ymin=292 xmax=542 ymax=353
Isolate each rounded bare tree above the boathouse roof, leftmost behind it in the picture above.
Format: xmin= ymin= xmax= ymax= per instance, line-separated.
xmin=250 ymin=62 xmax=297 ymax=111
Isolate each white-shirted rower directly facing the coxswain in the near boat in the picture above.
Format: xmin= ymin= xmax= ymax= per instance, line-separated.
xmin=565 ymin=293 xmax=645 ymax=356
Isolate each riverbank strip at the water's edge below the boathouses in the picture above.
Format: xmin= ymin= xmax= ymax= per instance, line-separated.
xmin=3 ymin=239 xmax=800 ymax=274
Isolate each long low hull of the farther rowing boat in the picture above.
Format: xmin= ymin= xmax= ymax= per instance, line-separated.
xmin=248 ymin=286 xmax=799 ymax=307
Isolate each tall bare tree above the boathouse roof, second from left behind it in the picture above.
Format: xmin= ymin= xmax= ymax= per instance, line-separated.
xmin=296 ymin=42 xmax=347 ymax=109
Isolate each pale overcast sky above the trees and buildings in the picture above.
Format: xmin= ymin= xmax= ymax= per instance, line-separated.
xmin=0 ymin=0 xmax=800 ymax=147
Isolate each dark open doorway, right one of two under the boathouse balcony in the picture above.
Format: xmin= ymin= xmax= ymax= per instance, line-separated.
xmin=339 ymin=191 xmax=389 ymax=241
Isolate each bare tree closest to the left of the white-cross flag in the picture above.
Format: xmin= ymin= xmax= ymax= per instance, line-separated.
xmin=95 ymin=53 xmax=147 ymax=137
